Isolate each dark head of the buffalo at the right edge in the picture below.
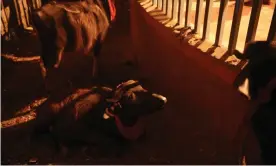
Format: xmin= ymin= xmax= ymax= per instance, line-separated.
xmin=234 ymin=41 xmax=276 ymax=100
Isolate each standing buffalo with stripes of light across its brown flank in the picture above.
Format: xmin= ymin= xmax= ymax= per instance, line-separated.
xmin=32 ymin=0 xmax=116 ymax=93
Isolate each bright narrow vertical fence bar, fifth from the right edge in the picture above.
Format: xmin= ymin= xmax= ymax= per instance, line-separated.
xmin=202 ymin=0 xmax=213 ymax=40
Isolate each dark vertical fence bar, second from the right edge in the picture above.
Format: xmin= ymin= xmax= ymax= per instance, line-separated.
xmin=245 ymin=0 xmax=263 ymax=44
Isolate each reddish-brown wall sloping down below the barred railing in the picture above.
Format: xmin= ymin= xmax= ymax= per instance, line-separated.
xmin=131 ymin=0 xmax=260 ymax=164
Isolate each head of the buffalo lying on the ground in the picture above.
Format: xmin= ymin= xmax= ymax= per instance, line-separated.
xmin=104 ymin=80 xmax=167 ymax=119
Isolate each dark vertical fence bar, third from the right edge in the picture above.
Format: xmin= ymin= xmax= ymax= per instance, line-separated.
xmin=227 ymin=0 xmax=244 ymax=55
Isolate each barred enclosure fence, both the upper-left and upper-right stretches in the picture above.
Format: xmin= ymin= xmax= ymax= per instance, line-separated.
xmin=1 ymin=0 xmax=276 ymax=55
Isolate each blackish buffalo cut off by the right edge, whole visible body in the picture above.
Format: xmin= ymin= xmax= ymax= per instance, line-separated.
xmin=235 ymin=41 xmax=276 ymax=164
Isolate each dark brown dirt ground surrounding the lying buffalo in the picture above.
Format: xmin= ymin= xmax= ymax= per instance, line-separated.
xmin=1 ymin=0 xmax=258 ymax=165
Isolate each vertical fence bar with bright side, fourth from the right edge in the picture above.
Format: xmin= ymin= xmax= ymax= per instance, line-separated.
xmin=214 ymin=0 xmax=228 ymax=46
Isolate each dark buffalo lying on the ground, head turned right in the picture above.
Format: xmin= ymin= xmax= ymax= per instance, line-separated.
xmin=31 ymin=80 xmax=167 ymax=157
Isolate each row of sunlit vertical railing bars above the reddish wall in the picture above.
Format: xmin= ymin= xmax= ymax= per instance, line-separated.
xmin=151 ymin=0 xmax=276 ymax=56
